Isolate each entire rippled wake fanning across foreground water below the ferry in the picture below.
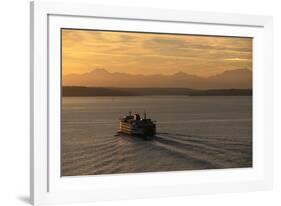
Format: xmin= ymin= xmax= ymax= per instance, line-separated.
xmin=63 ymin=132 xmax=252 ymax=175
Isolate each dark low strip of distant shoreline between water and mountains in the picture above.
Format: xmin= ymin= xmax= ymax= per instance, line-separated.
xmin=62 ymin=86 xmax=252 ymax=97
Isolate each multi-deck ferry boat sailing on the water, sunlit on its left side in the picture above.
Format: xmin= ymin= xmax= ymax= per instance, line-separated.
xmin=119 ymin=112 xmax=156 ymax=138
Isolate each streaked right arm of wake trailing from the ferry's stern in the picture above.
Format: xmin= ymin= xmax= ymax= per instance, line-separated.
xmin=153 ymin=132 xmax=252 ymax=169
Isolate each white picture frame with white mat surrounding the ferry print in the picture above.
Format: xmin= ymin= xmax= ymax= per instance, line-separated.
xmin=30 ymin=1 xmax=273 ymax=205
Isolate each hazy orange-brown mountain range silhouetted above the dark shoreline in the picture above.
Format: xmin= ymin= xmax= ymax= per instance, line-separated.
xmin=63 ymin=69 xmax=252 ymax=89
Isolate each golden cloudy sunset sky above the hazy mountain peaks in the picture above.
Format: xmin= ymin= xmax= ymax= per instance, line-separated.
xmin=62 ymin=29 xmax=252 ymax=76
